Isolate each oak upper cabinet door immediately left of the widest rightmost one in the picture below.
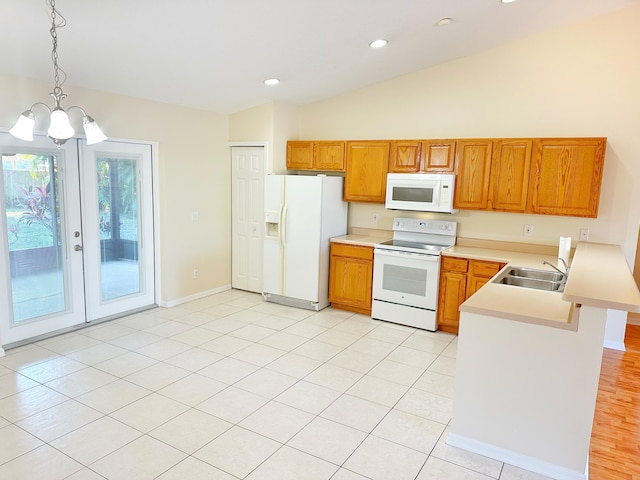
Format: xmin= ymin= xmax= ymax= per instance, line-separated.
xmin=489 ymin=139 xmax=533 ymax=212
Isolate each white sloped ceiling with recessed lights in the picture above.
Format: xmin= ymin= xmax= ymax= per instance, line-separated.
xmin=0 ymin=0 xmax=640 ymax=113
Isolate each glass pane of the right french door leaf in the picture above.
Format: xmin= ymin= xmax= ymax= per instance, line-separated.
xmin=97 ymin=157 xmax=140 ymax=301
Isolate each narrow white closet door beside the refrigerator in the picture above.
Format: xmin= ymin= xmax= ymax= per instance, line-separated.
xmin=231 ymin=147 xmax=265 ymax=292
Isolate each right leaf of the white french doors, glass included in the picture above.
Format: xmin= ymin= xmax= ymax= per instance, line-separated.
xmin=80 ymin=141 xmax=155 ymax=321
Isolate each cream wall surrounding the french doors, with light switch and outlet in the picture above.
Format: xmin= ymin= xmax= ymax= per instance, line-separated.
xmin=0 ymin=76 xmax=231 ymax=303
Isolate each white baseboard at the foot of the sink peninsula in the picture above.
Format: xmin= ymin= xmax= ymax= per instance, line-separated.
xmin=447 ymin=433 xmax=588 ymax=480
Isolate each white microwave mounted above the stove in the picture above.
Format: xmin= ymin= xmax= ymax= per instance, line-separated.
xmin=385 ymin=173 xmax=458 ymax=213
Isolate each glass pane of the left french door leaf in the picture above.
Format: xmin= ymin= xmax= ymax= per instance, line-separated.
xmin=2 ymin=153 xmax=67 ymax=324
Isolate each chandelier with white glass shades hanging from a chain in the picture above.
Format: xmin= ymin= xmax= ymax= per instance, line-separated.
xmin=9 ymin=0 xmax=107 ymax=147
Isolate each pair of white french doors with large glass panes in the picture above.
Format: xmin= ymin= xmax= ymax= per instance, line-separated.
xmin=0 ymin=133 xmax=155 ymax=345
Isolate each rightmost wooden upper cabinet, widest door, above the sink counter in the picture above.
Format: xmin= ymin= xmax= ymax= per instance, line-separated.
xmin=529 ymin=138 xmax=607 ymax=218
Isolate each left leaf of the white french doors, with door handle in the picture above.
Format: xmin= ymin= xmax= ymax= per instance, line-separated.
xmin=0 ymin=132 xmax=85 ymax=345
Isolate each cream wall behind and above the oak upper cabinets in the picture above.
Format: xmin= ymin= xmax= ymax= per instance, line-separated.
xmin=299 ymin=5 xmax=640 ymax=265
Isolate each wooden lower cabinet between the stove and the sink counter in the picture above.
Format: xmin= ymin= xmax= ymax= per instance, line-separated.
xmin=438 ymin=256 xmax=506 ymax=335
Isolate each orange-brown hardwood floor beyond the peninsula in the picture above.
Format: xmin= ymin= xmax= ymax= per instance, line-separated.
xmin=589 ymin=325 xmax=640 ymax=480
